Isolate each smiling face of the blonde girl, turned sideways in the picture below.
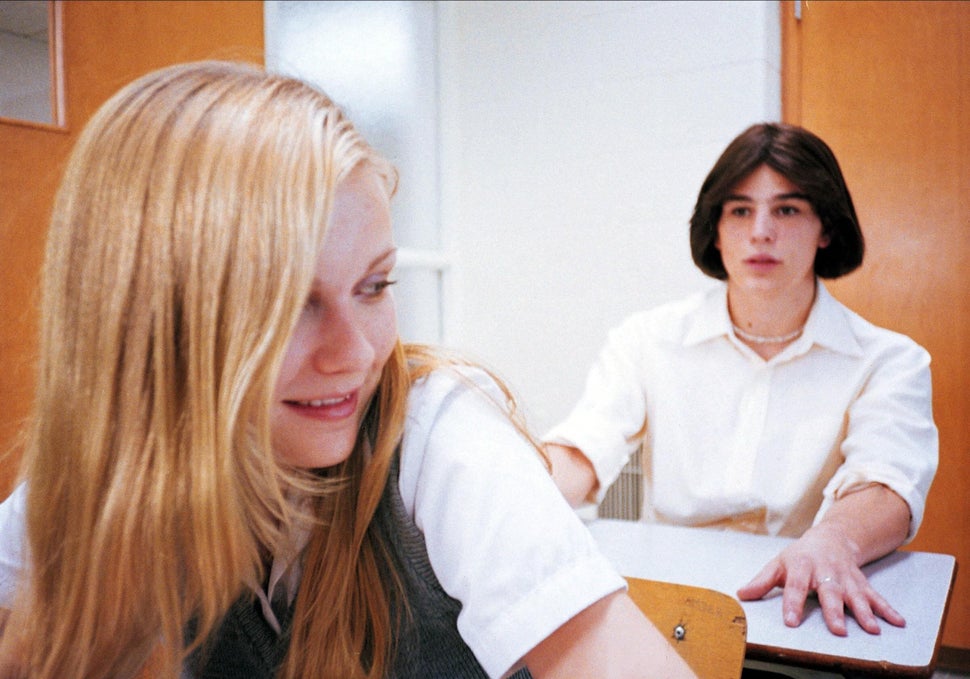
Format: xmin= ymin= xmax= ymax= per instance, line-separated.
xmin=272 ymin=168 xmax=397 ymax=468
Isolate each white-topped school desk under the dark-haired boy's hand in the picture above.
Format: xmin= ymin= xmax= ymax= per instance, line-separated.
xmin=587 ymin=519 xmax=956 ymax=677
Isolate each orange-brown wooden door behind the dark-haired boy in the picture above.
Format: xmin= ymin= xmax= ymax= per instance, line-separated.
xmin=781 ymin=1 xmax=970 ymax=649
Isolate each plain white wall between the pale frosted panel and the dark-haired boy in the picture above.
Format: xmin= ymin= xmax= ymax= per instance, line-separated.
xmin=434 ymin=0 xmax=780 ymax=431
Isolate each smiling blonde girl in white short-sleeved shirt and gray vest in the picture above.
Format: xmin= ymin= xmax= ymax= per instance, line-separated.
xmin=0 ymin=62 xmax=690 ymax=679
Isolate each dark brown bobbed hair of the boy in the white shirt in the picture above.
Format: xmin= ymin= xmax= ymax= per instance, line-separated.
xmin=690 ymin=123 xmax=865 ymax=280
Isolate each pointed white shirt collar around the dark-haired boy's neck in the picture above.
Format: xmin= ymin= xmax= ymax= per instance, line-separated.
xmin=683 ymin=281 xmax=862 ymax=356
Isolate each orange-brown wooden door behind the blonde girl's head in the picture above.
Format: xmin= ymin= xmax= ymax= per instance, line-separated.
xmin=0 ymin=0 xmax=264 ymax=497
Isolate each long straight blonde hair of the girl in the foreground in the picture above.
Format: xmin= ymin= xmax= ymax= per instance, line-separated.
xmin=3 ymin=62 xmax=409 ymax=679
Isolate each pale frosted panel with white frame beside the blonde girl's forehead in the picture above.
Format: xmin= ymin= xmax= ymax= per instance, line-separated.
xmin=263 ymin=0 xmax=449 ymax=342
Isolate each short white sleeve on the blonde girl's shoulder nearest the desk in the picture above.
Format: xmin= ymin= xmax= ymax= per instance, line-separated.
xmin=400 ymin=372 xmax=625 ymax=676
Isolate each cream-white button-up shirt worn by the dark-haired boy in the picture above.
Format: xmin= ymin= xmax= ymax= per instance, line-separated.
xmin=545 ymin=283 xmax=938 ymax=538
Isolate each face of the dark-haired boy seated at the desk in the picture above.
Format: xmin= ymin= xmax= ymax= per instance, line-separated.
xmin=717 ymin=165 xmax=829 ymax=294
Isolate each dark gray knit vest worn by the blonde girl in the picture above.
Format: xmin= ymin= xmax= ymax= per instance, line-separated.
xmin=186 ymin=458 xmax=532 ymax=679
